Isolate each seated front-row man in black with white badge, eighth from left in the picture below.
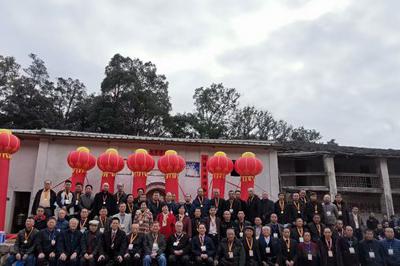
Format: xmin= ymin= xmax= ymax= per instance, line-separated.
xmin=167 ymin=221 xmax=190 ymax=266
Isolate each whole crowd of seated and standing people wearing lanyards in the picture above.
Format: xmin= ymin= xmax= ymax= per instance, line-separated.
xmin=7 ymin=180 xmax=400 ymax=266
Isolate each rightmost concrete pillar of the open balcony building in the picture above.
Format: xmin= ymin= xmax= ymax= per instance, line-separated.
xmin=377 ymin=158 xmax=394 ymax=216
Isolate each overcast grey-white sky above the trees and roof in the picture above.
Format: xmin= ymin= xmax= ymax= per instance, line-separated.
xmin=0 ymin=0 xmax=400 ymax=148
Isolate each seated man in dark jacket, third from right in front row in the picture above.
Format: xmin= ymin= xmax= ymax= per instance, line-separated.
xmin=336 ymin=226 xmax=360 ymax=266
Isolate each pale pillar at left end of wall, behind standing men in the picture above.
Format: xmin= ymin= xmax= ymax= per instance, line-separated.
xmin=29 ymin=139 xmax=49 ymax=213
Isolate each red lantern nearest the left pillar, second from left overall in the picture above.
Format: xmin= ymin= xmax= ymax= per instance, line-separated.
xmin=67 ymin=147 xmax=96 ymax=191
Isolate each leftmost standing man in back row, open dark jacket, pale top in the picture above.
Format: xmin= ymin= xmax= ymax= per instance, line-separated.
xmin=31 ymin=180 xmax=57 ymax=217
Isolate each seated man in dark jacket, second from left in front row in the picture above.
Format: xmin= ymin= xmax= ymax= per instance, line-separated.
xmin=35 ymin=217 xmax=60 ymax=266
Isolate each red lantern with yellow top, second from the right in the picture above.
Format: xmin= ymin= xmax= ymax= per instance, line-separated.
xmin=207 ymin=151 xmax=233 ymax=198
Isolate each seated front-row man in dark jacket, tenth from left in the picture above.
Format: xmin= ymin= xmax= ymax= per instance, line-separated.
xmin=215 ymin=228 xmax=246 ymax=266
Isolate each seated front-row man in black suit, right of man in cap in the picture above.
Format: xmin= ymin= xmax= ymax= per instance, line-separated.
xmin=97 ymin=217 xmax=127 ymax=265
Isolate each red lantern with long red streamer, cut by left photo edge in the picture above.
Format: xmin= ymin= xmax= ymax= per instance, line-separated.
xmin=0 ymin=129 xmax=21 ymax=231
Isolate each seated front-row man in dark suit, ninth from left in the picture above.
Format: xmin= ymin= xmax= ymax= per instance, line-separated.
xmin=192 ymin=223 xmax=215 ymax=266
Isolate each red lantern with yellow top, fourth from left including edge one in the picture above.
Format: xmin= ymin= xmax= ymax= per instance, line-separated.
xmin=126 ymin=149 xmax=155 ymax=197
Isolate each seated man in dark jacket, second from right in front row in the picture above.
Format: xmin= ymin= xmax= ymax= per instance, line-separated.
xmin=359 ymin=229 xmax=385 ymax=266
